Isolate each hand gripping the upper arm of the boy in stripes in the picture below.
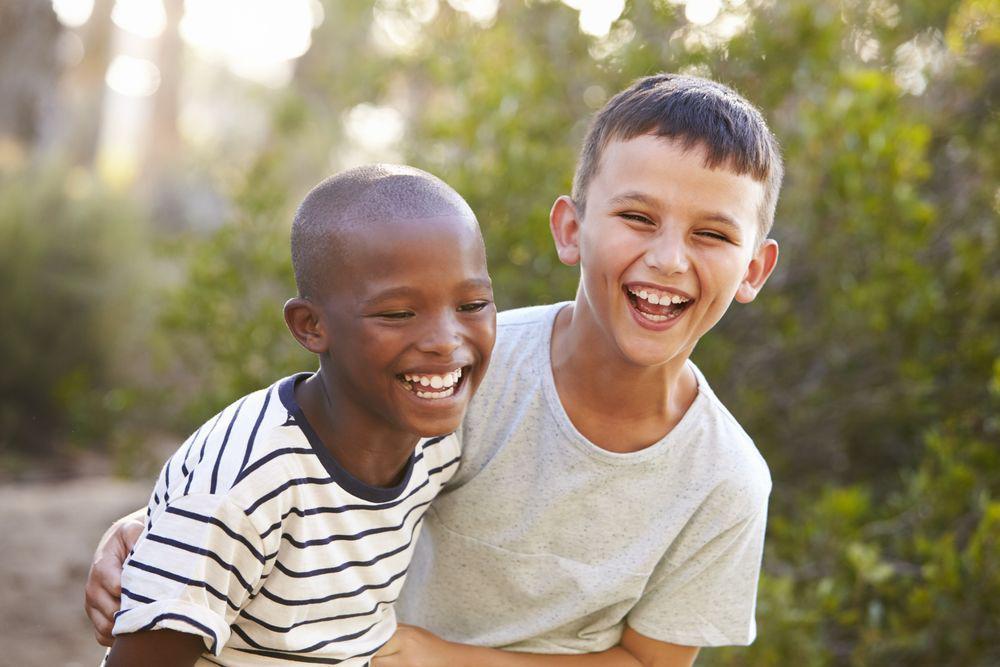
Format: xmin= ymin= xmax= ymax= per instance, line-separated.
xmin=84 ymin=512 xmax=144 ymax=646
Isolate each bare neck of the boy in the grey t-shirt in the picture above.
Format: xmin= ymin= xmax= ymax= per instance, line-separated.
xmin=551 ymin=304 xmax=698 ymax=452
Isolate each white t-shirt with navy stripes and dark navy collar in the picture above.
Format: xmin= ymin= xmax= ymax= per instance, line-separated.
xmin=114 ymin=374 xmax=459 ymax=667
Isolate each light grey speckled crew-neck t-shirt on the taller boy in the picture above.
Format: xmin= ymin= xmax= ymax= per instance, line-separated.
xmin=397 ymin=304 xmax=771 ymax=653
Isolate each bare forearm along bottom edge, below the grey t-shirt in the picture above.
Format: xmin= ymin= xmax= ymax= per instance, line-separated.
xmin=372 ymin=625 xmax=698 ymax=667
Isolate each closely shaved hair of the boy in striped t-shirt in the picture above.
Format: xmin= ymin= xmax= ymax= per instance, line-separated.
xmin=291 ymin=164 xmax=475 ymax=298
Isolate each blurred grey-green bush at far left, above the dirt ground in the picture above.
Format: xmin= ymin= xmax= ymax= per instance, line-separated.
xmin=0 ymin=166 xmax=150 ymax=466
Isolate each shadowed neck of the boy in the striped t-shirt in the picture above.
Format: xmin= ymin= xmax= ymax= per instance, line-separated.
xmin=295 ymin=371 xmax=420 ymax=487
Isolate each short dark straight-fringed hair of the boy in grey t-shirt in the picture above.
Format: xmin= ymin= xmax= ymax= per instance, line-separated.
xmin=573 ymin=73 xmax=784 ymax=243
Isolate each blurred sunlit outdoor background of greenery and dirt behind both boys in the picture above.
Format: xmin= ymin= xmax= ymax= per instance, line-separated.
xmin=0 ymin=0 xmax=1000 ymax=666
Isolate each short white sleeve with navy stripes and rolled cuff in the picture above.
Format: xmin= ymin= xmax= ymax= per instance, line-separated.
xmin=114 ymin=494 xmax=265 ymax=655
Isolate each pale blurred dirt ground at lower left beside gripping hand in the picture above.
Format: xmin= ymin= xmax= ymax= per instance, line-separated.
xmin=0 ymin=476 xmax=151 ymax=667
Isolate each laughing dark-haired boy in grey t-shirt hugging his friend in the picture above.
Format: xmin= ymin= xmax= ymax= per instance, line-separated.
xmin=90 ymin=74 xmax=782 ymax=667
